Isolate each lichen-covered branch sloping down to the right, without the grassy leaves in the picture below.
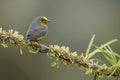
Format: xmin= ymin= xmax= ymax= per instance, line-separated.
xmin=0 ymin=28 xmax=120 ymax=80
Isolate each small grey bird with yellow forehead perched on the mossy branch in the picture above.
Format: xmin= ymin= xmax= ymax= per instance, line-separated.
xmin=26 ymin=16 xmax=50 ymax=42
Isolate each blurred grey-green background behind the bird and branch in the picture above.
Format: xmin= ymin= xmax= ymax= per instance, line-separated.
xmin=0 ymin=0 xmax=120 ymax=80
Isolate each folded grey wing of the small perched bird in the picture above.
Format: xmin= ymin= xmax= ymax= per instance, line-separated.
xmin=26 ymin=25 xmax=47 ymax=40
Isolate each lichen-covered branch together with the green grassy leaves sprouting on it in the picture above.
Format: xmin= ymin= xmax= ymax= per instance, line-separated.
xmin=0 ymin=28 xmax=120 ymax=80
